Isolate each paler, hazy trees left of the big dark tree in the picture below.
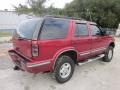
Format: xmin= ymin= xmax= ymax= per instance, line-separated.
xmin=14 ymin=0 xmax=63 ymax=16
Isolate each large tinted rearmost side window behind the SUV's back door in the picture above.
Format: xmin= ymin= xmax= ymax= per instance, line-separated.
xmin=40 ymin=19 xmax=69 ymax=40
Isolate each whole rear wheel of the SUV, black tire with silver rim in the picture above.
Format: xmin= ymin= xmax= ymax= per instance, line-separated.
xmin=54 ymin=55 xmax=75 ymax=83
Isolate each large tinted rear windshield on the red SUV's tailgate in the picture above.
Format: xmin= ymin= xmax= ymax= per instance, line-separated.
xmin=17 ymin=19 xmax=40 ymax=39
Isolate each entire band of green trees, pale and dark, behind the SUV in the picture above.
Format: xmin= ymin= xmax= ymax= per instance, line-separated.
xmin=15 ymin=0 xmax=120 ymax=28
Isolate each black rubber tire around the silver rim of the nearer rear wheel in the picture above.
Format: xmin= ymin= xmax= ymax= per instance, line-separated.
xmin=53 ymin=55 xmax=75 ymax=83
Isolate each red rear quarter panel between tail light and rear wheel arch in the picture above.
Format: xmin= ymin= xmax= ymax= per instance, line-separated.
xmin=33 ymin=21 xmax=73 ymax=68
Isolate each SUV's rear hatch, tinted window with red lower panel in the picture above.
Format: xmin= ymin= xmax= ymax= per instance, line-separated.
xmin=13 ymin=19 xmax=40 ymax=58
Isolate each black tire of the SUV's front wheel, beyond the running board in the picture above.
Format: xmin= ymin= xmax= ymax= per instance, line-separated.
xmin=103 ymin=46 xmax=114 ymax=62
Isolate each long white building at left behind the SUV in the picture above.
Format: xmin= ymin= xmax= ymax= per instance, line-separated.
xmin=0 ymin=10 xmax=30 ymax=32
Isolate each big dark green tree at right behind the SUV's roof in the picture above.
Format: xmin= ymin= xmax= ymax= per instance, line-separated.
xmin=65 ymin=0 xmax=120 ymax=28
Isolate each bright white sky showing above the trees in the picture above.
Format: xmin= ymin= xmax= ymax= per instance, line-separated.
xmin=0 ymin=0 xmax=73 ymax=10
